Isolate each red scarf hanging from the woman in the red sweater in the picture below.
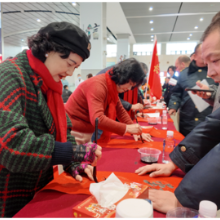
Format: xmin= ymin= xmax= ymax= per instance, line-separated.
xmin=99 ymin=69 xmax=118 ymax=142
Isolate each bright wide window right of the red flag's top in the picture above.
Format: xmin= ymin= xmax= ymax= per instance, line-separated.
xmin=166 ymin=42 xmax=197 ymax=55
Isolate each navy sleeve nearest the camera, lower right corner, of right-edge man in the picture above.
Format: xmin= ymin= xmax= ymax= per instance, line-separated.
xmin=175 ymin=144 xmax=220 ymax=210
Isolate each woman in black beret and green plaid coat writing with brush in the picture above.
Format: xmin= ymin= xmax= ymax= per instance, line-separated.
xmin=0 ymin=22 xmax=101 ymax=218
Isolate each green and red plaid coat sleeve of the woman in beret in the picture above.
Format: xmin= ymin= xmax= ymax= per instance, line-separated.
xmin=0 ymin=68 xmax=55 ymax=173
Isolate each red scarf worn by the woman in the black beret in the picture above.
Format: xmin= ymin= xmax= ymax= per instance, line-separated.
xmin=27 ymin=50 xmax=67 ymax=142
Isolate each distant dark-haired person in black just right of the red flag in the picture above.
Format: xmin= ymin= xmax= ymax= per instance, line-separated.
xmin=163 ymin=66 xmax=178 ymax=106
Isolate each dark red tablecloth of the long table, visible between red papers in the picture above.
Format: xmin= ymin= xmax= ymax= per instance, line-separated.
xmin=13 ymin=117 xmax=184 ymax=219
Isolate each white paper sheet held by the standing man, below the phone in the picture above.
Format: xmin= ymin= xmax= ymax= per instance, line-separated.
xmin=188 ymin=79 xmax=209 ymax=112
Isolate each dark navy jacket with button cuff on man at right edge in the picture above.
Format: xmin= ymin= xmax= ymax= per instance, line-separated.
xmin=170 ymin=108 xmax=220 ymax=210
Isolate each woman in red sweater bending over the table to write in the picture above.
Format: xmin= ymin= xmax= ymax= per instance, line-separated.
xmin=65 ymin=58 xmax=151 ymax=143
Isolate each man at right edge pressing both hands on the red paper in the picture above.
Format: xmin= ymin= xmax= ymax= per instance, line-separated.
xmin=136 ymin=18 xmax=220 ymax=213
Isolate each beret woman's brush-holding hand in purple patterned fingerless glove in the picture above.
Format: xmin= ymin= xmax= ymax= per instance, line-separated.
xmin=72 ymin=142 xmax=102 ymax=166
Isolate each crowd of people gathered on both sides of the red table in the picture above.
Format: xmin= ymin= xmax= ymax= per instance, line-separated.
xmin=0 ymin=9 xmax=220 ymax=218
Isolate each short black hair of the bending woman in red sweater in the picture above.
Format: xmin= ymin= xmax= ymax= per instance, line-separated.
xmin=109 ymin=58 xmax=145 ymax=87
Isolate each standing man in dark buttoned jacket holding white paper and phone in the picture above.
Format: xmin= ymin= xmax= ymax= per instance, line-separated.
xmin=169 ymin=44 xmax=217 ymax=136
